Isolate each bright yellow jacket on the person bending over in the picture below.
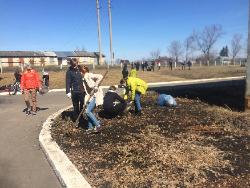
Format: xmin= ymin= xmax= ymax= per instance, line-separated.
xmin=127 ymin=77 xmax=148 ymax=100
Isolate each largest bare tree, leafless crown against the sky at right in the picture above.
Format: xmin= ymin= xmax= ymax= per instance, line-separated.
xmin=193 ymin=25 xmax=223 ymax=61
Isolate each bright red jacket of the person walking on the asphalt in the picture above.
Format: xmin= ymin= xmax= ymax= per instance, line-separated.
xmin=21 ymin=69 xmax=41 ymax=89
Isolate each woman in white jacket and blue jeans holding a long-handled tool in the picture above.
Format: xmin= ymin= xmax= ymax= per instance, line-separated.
xmin=80 ymin=66 xmax=103 ymax=132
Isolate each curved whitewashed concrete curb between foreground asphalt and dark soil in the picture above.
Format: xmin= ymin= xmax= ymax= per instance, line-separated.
xmin=39 ymin=106 xmax=91 ymax=188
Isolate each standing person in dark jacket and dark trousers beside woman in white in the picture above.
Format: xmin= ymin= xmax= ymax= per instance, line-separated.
xmin=66 ymin=58 xmax=85 ymax=118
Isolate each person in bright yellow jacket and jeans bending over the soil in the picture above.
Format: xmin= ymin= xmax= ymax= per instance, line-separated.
xmin=124 ymin=76 xmax=148 ymax=116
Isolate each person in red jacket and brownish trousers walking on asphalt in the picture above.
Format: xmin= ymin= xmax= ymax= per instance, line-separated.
xmin=21 ymin=64 xmax=41 ymax=115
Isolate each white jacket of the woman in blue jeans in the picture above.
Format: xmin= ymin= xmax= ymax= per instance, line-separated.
xmin=83 ymin=73 xmax=103 ymax=106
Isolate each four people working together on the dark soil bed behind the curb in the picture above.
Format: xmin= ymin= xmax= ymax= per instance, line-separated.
xmin=66 ymin=58 xmax=147 ymax=132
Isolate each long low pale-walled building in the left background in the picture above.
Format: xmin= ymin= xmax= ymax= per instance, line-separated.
xmin=0 ymin=51 xmax=105 ymax=67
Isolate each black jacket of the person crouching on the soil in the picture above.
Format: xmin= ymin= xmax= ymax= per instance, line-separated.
xmin=103 ymin=91 xmax=126 ymax=111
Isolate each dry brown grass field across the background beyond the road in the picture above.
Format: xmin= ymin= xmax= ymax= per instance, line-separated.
xmin=0 ymin=66 xmax=246 ymax=89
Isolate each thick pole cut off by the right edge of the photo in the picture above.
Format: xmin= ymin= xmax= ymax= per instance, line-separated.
xmin=245 ymin=0 xmax=250 ymax=110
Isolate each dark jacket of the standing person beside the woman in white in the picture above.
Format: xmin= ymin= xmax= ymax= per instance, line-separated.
xmin=66 ymin=67 xmax=84 ymax=93
